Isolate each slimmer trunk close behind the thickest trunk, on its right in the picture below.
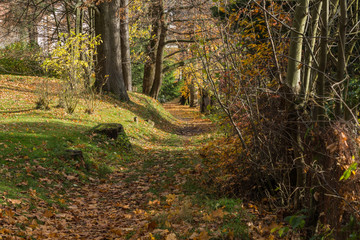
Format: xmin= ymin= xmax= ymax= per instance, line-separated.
xmin=120 ymin=0 xmax=132 ymax=91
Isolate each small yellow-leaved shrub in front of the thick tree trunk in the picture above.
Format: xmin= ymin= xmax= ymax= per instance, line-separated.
xmin=42 ymin=32 xmax=100 ymax=114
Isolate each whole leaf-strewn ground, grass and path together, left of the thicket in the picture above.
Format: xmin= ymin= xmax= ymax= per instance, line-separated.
xmin=0 ymin=75 xmax=282 ymax=240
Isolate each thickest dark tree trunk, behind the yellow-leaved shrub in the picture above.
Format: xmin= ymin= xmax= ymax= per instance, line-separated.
xmin=95 ymin=0 xmax=129 ymax=101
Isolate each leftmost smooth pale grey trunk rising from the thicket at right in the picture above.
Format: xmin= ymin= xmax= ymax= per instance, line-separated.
xmin=286 ymin=0 xmax=309 ymax=94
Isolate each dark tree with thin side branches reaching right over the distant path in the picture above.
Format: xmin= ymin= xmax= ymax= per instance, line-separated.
xmin=143 ymin=0 xmax=210 ymax=99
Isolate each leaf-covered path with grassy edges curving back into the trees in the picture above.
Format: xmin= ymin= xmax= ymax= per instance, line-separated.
xmin=43 ymin=101 xmax=217 ymax=240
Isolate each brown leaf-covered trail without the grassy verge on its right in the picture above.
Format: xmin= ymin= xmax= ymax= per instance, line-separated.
xmin=38 ymin=102 xmax=211 ymax=239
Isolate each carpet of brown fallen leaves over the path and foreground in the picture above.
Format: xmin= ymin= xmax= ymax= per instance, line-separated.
xmin=0 ymin=84 xmax=294 ymax=240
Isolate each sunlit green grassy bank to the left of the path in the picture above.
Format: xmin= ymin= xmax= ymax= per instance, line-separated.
xmin=0 ymin=75 xmax=175 ymax=202
